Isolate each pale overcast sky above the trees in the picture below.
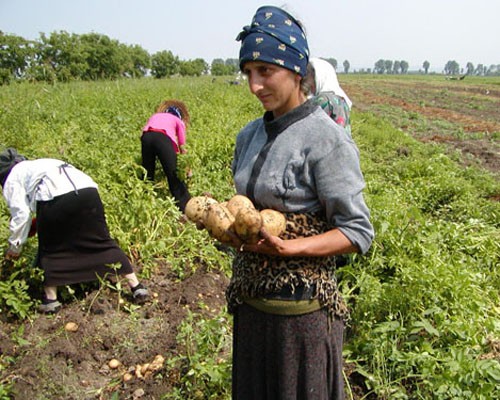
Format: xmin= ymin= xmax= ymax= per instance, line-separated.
xmin=0 ymin=0 xmax=500 ymax=72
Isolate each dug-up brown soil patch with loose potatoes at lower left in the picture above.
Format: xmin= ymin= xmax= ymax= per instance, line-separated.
xmin=0 ymin=265 xmax=228 ymax=400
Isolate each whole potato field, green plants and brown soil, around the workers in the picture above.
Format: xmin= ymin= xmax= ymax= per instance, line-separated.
xmin=0 ymin=74 xmax=500 ymax=400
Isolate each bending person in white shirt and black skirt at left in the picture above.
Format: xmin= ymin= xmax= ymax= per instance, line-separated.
xmin=0 ymin=148 xmax=149 ymax=313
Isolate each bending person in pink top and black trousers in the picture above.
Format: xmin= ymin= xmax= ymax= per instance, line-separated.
xmin=141 ymin=100 xmax=191 ymax=212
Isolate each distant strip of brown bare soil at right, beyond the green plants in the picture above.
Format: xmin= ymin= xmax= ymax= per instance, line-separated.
xmin=344 ymin=78 xmax=500 ymax=176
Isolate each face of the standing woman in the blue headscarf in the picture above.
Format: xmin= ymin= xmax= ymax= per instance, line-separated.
xmin=243 ymin=61 xmax=305 ymax=117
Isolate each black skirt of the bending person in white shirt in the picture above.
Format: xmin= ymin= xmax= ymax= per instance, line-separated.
xmin=37 ymin=188 xmax=133 ymax=286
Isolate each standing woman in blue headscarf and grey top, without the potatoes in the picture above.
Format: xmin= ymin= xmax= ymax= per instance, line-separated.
xmin=226 ymin=6 xmax=373 ymax=400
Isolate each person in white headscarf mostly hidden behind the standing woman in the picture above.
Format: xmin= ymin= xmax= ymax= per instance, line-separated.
xmin=305 ymin=57 xmax=352 ymax=135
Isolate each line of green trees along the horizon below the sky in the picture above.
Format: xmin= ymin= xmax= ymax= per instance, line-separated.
xmin=0 ymin=31 xmax=500 ymax=84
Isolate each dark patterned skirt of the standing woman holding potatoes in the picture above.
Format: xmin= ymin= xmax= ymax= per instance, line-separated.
xmin=232 ymin=304 xmax=344 ymax=400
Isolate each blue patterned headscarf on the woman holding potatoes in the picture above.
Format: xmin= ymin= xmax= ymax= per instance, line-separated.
xmin=236 ymin=6 xmax=309 ymax=76
